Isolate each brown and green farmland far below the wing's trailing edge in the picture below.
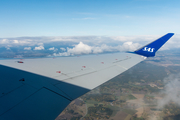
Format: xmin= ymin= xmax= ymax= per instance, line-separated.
xmin=57 ymin=51 xmax=180 ymax=120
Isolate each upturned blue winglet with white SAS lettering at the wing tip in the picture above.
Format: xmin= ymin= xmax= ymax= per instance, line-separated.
xmin=134 ymin=33 xmax=174 ymax=57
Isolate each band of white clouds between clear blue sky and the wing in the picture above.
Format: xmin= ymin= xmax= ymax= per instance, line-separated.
xmin=0 ymin=35 xmax=180 ymax=56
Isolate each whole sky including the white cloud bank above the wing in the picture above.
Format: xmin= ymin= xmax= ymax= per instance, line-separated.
xmin=0 ymin=0 xmax=180 ymax=56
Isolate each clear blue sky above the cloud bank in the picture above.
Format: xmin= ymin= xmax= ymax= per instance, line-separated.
xmin=0 ymin=0 xmax=180 ymax=38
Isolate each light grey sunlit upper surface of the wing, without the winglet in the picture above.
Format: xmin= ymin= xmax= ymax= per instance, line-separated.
xmin=0 ymin=53 xmax=144 ymax=89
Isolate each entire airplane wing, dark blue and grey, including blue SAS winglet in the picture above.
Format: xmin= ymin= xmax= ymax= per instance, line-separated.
xmin=0 ymin=33 xmax=174 ymax=120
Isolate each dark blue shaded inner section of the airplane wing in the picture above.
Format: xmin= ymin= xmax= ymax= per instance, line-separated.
xmin=0 ymin=65 xmax=89 ymax=120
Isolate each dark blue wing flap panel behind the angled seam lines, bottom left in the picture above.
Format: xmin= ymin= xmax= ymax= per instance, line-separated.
xmin=0 ymin=88 xmax=70 ymax=120
